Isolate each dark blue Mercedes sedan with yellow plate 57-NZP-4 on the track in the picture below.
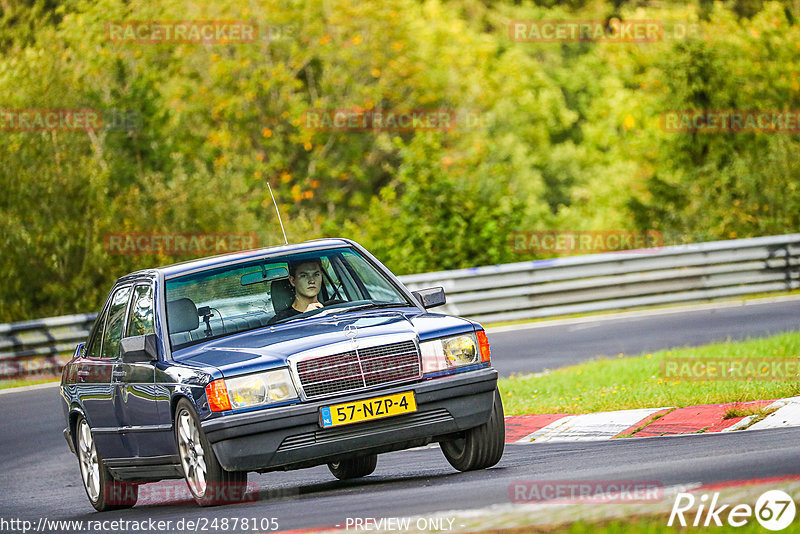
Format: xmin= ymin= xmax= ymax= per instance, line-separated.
xmin=61 ymin=239 xmax=504 ymax=511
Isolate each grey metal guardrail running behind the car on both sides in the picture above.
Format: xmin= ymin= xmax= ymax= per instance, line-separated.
xmin=0 ymin=234 xmax=800 ymax=379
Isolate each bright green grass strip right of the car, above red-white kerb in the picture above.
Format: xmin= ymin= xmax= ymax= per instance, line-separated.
xmin=499 ymin=333 xmax=800 ymax=415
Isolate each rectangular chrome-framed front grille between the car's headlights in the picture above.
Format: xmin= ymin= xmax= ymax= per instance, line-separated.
xmin=297 ymin=341 xmax=421 ymax=398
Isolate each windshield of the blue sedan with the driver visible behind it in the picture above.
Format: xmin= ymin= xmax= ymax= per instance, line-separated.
xmin=166 ymin=248 xmax=410 ymax=349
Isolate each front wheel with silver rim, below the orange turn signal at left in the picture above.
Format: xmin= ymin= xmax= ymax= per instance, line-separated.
xmin=175 ymin=399 xmax=247 ymax=506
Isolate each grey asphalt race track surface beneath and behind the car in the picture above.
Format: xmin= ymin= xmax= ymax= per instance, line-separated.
xmin=0 ymin=303 xmax=800 ymax=532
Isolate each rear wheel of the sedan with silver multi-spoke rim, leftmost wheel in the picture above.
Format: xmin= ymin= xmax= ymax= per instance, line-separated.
xmin=75 ymin=416 xmax=139 ymax=512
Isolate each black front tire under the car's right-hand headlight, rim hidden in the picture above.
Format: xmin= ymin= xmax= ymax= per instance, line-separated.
xmin=440 ymin=389 xmax=506 ymax=471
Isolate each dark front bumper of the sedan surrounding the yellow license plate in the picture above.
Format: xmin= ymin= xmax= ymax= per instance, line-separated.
xmin=202 ymin=368 xmax=497 ymax=471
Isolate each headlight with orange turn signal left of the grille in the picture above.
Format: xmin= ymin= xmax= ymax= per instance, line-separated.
xmin=206 ymin=369 xmax=297 ymax=412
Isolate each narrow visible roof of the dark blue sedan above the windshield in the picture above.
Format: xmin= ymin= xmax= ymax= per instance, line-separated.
xmin=118 ymin=238 xmax=354 ymax=283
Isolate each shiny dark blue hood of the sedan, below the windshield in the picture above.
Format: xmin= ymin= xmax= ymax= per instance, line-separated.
xmin=173 ymin=308 xmax=474 ymax=377
